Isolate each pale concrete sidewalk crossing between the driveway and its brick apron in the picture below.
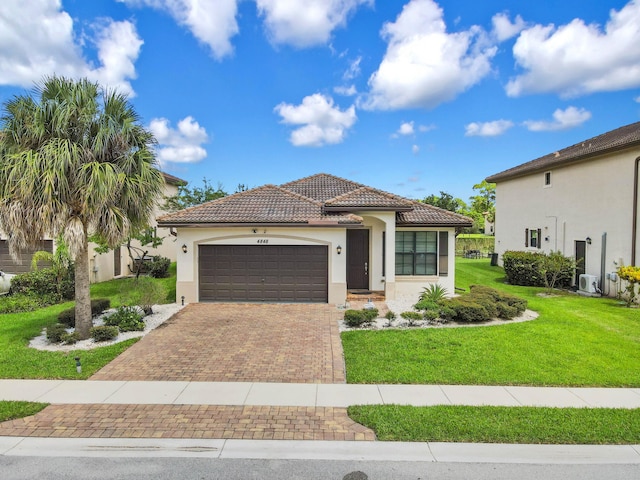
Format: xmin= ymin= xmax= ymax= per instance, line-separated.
xmin=0 ymin=380 xmax=640 ymax=408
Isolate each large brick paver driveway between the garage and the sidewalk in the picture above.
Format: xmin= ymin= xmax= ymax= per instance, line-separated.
xmin=92 ymin=303 xmax=345 ymax=383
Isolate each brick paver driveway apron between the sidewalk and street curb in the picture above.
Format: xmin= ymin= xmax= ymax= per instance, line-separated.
xmin=0 ymin=404 xmax=375 ymax=440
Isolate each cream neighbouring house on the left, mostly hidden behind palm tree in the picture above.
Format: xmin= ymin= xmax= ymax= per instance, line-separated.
xmin=0 ymin=172 xmax=187 ymax=283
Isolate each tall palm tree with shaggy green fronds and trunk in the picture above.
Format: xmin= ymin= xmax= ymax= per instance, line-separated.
xmin=0 ymin=76 xmax=164 ymax=338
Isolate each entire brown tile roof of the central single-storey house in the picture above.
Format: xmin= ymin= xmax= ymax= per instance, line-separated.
xmin=158 ymin=173 xmax=472 ymax=227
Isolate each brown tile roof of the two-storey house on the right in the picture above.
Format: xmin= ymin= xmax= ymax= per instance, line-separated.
xmin=486 ymin=122 xmax=640 ymax=183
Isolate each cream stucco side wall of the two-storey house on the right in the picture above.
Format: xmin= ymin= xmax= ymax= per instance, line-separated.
xmin=495 ymin=149 xmax=640 ymax=293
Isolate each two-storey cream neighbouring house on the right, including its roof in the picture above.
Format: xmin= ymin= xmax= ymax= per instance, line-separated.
xmin=486 ymin=122 xmax=640 ymax=295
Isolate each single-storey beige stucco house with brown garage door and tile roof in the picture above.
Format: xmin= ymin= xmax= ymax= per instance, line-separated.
xmin=158 ymin=174 xmax=472 ymax=304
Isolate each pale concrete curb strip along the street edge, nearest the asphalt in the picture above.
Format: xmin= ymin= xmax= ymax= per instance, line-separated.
xmin=0 ymin=437 xmax=640 ymax=465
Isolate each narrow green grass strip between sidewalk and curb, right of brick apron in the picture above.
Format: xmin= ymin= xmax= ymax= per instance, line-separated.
xmin=348 ymin=405 xmax=640 ymax=445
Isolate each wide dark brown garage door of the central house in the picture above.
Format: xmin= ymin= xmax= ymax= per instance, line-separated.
xmin=198 ymin=245 xmax=328 ymax=303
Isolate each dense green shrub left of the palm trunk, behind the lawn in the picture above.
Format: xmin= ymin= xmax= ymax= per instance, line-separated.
xmin=11 ymin=268 xmax=75 ymax=303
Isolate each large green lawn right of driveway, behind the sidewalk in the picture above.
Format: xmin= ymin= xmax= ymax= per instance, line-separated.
xmin=342 ymin=258 xmax=640 ymax=387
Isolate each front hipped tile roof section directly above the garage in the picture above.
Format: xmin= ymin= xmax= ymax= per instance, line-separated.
xmin=158 ymin=185 xmax=362 ymax=224
